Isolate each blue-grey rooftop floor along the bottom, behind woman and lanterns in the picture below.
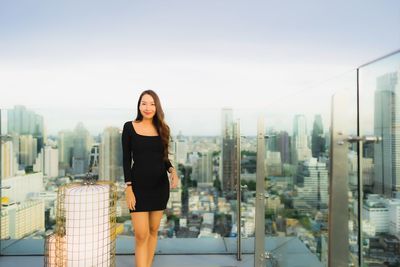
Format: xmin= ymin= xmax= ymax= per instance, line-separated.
xmin=0 ymin=237 xmax=323 ymax=267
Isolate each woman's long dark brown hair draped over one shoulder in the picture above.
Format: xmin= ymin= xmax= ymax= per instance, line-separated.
xmin=135 ymin=90 xmax=170 ymax=160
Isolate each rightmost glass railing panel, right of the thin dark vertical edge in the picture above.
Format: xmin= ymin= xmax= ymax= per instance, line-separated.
xmin=359 ymin=52 xmax=400 ymax=266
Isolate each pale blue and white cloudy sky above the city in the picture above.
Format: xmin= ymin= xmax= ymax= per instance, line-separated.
xmin=0 ymin=0 xmax=400 ymax=134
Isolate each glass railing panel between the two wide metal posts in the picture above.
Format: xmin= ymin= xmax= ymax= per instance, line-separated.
xmin=248 ymin=70 xmax=356 ymax=266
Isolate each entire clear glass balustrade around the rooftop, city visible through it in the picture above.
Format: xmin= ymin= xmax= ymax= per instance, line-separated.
xmin=0 ymin=50 xmax=400 ymax=266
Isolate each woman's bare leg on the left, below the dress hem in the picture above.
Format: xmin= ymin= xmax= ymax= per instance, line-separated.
xmin=131 ymin=212 xmax=149 ymax=267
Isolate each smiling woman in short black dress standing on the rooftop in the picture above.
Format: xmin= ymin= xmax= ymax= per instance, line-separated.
xmin=122 ymin=90 xmax=178 ymax=267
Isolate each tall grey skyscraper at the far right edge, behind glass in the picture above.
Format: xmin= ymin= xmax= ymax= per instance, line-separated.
xmin=374 ymin=72 xmax=400 ymax=197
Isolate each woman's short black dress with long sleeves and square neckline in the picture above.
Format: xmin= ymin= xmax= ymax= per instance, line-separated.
xmin=122 ymin=121 xmax=172 ymax=212
